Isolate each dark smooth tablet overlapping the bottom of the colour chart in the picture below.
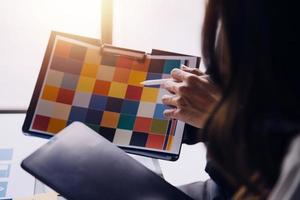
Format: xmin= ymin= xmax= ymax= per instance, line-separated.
xmin=21 ymin=122 xmax=191 ymax=200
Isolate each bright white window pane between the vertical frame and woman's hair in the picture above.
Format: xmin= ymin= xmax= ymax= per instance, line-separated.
xmin=113 ymin=0 xmax=204 ymax=55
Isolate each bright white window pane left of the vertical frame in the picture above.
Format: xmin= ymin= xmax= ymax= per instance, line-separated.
xmin=0 ymin=0 xmax=101 ymax=109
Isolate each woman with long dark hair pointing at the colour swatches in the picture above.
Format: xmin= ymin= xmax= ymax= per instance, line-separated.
xmin=163 ymin=0 xmax=300 ymax=199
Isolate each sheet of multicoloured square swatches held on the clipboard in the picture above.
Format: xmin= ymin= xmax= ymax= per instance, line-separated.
xmin=30 ymin=36 xmax=196 ymax=153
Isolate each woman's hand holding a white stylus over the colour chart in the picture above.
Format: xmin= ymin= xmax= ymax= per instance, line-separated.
xmin=162 ymin=66 xmax=221 ymax=128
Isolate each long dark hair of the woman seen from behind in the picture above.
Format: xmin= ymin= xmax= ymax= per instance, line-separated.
xmin=202 ymin=0 xmax=300 ymax=197
